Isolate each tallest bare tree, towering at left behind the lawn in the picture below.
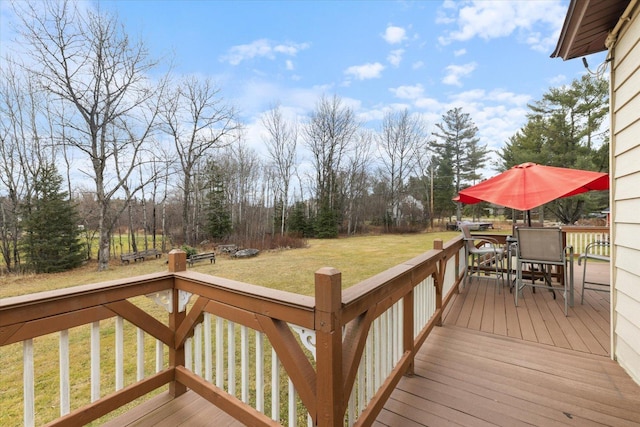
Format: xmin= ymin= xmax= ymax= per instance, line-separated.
xmin=16 ymin=0 xmax=169 ymax=270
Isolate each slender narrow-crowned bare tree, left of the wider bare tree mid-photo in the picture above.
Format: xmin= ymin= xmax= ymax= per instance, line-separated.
xmin=262 ymin=105 xmax=298 ymax=235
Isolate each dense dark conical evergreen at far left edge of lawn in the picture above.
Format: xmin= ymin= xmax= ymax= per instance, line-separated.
xmin=21 ymin=165 xmax=85 ymax=273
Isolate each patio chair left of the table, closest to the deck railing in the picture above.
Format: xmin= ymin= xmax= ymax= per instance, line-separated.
xmin=459 ymin=224 xmax=505 ymax=292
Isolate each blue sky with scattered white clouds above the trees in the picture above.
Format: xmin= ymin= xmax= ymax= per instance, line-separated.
xmin=0 ymin=0 xmax=604 ymax=177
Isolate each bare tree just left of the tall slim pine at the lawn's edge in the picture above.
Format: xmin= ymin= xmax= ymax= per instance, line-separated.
xmin=378 ymin=109 xmax=428 ymax=226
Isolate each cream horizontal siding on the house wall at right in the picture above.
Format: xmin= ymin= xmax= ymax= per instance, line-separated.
xmin=610 ymin=0 xmax=640 ymax=383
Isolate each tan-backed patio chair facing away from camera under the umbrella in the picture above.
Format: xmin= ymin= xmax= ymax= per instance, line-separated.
xmin=515 ymin=227 xmax=573 ymax=316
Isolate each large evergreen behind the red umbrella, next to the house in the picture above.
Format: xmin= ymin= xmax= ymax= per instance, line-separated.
xmin=500 ymin=75 xmax=609 ymax=224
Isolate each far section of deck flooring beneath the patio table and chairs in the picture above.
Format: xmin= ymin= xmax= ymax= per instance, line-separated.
xmin=444 ymin=263 xmax=611 ymax=356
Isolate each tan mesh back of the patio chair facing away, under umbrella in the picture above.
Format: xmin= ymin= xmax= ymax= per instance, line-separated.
xmin=516 ymin=227 xmax=565 ymax=264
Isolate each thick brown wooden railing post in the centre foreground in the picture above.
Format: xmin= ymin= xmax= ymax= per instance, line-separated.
xmin=315 ymin=267 xmax=345 ymax=427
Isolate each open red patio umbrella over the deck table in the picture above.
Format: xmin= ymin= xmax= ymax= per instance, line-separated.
xmin=454 ymin=163 xmax=609 ymax=226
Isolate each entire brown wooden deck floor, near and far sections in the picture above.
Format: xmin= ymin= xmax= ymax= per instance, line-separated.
xmin=107 ymin=265 xmax=640 ymax=427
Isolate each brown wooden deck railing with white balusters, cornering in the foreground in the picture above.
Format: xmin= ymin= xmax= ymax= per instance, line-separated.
xmin=0 ymin=238 xmax=464 ymax=426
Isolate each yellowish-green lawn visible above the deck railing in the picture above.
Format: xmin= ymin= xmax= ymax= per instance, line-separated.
xmin=0 ymin=232 xmax=459 ymax=298
